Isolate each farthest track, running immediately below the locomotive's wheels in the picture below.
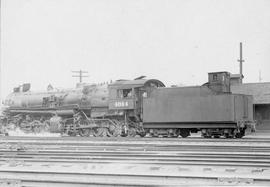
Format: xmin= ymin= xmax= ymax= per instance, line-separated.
xmin=0 ymin=137 xmax=270 ymax=147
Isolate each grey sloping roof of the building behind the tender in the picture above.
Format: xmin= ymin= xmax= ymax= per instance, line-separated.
xmin=231 ymin=82 xmax=270 ymax=104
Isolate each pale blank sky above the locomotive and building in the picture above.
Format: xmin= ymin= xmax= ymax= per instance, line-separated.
xmin=1 ymin=0 xmax=270 ymax=97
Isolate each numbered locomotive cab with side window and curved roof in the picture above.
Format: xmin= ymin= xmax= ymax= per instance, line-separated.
xmin=109 ymin=79 xmax=165 ymax=120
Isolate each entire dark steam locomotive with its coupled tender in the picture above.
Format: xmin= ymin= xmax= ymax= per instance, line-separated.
xmin=2 ymin=72 xmax=253 ymax=138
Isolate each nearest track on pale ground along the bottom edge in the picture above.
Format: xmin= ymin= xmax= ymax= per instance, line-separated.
xmin=0 ymin=163 xmax=270 ymax=186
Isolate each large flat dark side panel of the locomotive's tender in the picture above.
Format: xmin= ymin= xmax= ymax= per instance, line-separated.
xmin=143 ymin=88 xmax=235 ymax=124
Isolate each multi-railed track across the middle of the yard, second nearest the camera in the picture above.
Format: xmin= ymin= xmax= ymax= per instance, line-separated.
xmin=0 ymin=153 xmax=270 ymax=169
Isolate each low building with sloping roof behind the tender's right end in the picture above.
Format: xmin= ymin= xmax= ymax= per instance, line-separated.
xmin=231 ymin=82 xmax=270 ymax=130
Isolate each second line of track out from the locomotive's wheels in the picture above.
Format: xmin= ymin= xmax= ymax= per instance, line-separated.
xmin=0 ymin=142 xmax=270 ymax=154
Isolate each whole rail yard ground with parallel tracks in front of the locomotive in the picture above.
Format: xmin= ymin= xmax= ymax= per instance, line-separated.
xmin=0 ymin=131 xmax=270 ymax=186
